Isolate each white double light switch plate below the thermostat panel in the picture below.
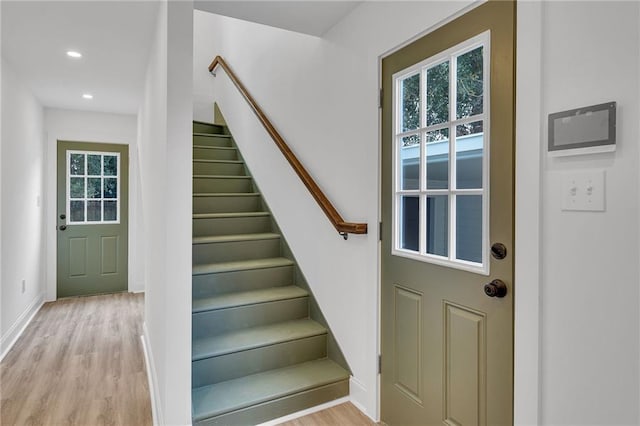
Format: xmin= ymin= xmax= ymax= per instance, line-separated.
xmin=562 ymin=170 xmax=605 ymax=212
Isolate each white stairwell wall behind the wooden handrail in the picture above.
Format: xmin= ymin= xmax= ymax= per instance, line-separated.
xmin=194 ymin=2 xmax=476 ymax=418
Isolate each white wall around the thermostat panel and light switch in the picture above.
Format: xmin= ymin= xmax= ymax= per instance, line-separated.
xmin=536 ymin=1 xmax=640 ymax=425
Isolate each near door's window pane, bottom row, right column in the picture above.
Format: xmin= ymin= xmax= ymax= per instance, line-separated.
xmin=456 ymin=195 xmax=482 ymax=263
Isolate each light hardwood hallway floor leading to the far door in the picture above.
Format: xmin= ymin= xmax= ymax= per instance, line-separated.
xmin=0 ymin=293 xmax=152 ymax=426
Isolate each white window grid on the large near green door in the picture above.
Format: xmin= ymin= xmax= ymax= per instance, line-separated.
xmin=392 ymin=31 xmax=491 ymax=275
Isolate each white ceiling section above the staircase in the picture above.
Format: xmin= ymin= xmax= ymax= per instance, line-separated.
xmin=194 ymin=0 xmax=362 ymax=36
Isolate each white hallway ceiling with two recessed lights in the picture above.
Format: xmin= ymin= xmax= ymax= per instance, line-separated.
xmin=1 ymin=0 xmax=158 ymax=114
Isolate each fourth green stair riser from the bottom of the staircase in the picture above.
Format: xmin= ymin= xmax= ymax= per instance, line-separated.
xmin=192 ymin=266 xmax=293 ymax=299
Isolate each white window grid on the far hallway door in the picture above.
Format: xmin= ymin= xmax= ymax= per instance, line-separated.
xmin=65 ymin=150 xmax=121 ymax=225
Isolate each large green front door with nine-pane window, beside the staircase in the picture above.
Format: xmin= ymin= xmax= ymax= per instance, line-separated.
xmin=381 ymin=1 xmax=515 ymax=426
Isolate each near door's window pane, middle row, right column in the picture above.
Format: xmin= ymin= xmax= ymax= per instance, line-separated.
xmin=456 ymin=121 xmax=484 ymax=189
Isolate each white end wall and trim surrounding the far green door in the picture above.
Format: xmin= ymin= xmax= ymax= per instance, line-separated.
xmin=44 ymin=108 xmax=144 ymax=300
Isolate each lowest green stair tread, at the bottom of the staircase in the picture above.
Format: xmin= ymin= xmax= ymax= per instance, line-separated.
xmin=191 ymin=359 xmax=349 ymax=421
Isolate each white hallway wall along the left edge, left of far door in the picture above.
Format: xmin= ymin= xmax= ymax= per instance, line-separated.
xmin=0 ymin=55 xmax=45 ymax=356
